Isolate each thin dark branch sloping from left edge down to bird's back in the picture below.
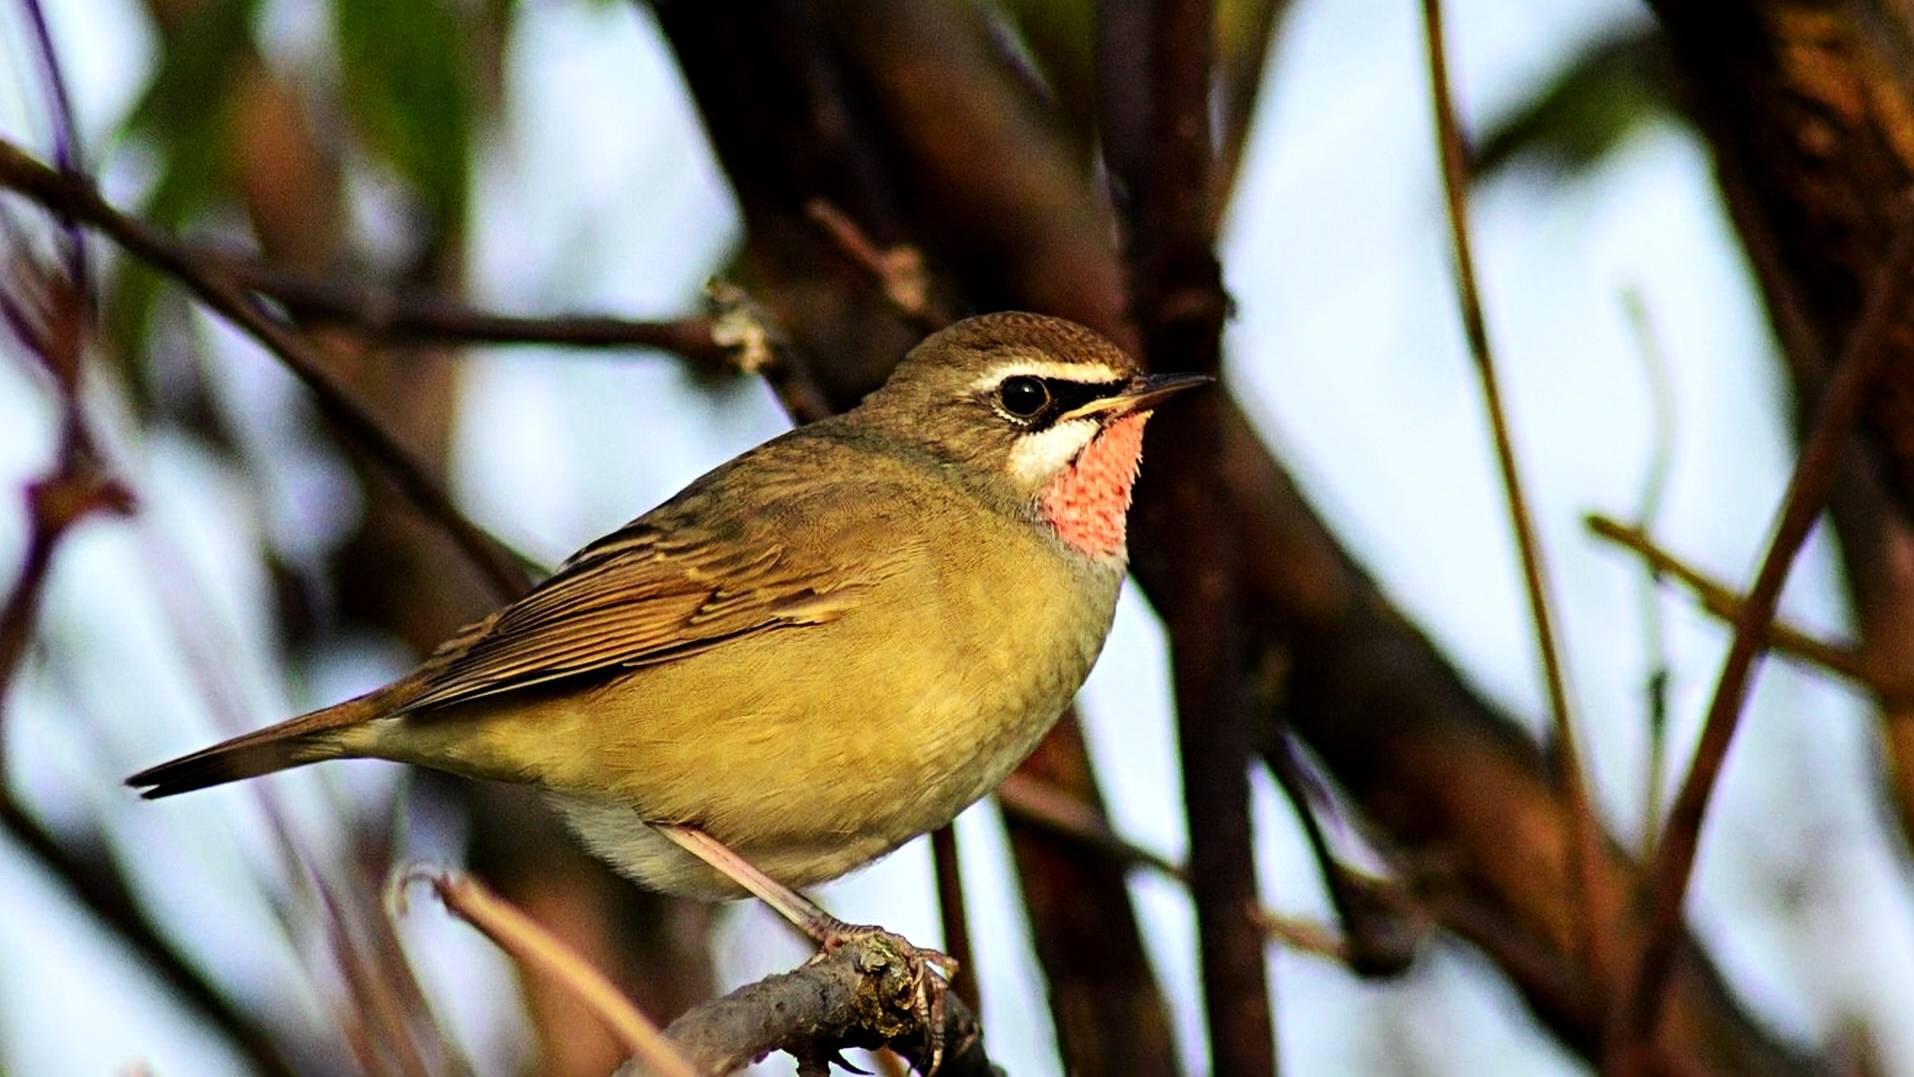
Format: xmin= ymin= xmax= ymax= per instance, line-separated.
xmin=0 ymin=142 xmax=528 ymax=599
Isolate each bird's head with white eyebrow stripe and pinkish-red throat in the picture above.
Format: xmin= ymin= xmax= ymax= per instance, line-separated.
xmin=859 ymin=312 xmax=1212 ymax=560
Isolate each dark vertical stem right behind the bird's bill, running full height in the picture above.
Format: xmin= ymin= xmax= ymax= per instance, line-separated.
xmin=1097 ymin=0 xmax=1277 ymax=1077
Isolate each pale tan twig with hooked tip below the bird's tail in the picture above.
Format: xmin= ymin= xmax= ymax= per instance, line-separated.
xmin=394 ymin=868 xmax=699 ymax=1077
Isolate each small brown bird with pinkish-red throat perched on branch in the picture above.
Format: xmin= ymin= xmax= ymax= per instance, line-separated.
xmin=128 ymin=314 xmax=1210 ymax=967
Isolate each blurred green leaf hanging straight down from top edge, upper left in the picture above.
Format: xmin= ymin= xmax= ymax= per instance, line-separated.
xmin=333 ymin=0 xmax=473 ymax=228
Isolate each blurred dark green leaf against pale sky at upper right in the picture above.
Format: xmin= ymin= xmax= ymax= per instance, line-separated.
xmin=1476 ymin=23 xmax=1680 ymax=180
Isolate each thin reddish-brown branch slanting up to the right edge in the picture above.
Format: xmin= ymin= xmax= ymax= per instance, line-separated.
xmin=1623 ymin=212 xmax=1914 ymax=1058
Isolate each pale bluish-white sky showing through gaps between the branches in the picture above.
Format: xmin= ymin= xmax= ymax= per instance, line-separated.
xmin=0 ymin=0 xmax=1914 ymax=1075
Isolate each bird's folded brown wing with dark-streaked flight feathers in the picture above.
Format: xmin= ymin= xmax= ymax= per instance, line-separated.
xmin=398 ymin=522 xmax=852 ymax=714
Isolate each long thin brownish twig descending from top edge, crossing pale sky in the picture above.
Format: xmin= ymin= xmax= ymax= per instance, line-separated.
xmin=1422 ymin=0 xmax=1612 ymax=1025
